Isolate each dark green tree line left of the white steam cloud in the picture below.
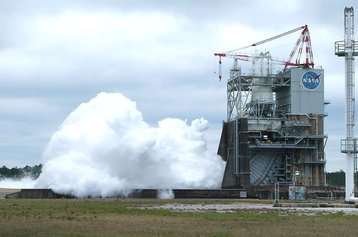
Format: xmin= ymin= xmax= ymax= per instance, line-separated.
xmin=0 ymin=164 xmax=42 ymax=179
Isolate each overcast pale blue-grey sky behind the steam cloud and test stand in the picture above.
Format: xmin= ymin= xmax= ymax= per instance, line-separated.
xmin=0 ymin=0 xmax=358 ymax=171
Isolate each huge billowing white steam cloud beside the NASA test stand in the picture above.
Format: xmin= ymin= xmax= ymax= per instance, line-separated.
xmin=36 ymin=92 xmax=224 ymax=197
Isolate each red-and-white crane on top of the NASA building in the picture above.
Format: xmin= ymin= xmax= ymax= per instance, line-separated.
xmin=214 ymin=25 xmax=314 ymax=80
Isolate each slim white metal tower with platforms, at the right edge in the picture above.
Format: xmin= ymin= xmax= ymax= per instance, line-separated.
xmin=335 ymin=7 xmax=358 ymax=201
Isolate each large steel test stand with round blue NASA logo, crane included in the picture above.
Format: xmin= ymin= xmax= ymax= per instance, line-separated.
xmin=215 ymin=25 xmax=327 ymax=192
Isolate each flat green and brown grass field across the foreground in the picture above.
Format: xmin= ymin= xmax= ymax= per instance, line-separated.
xmin=0 ymin=199 xmax=358 ymax=237
